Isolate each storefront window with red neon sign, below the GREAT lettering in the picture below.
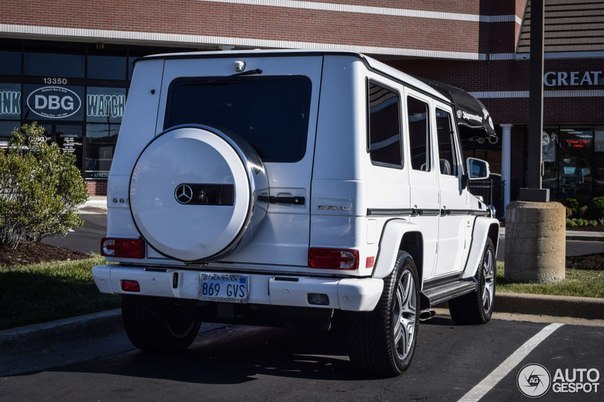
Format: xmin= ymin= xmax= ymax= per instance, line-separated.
xmin=559 ymin=127 xmax=594 ymax=197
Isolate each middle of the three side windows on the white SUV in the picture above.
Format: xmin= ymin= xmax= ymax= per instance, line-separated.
xmin=407 ymin=97 xmax=432 ymax=172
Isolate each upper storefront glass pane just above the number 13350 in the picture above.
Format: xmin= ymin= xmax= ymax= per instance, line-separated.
xmin=24 ymin=52 xmax=85 ymax=78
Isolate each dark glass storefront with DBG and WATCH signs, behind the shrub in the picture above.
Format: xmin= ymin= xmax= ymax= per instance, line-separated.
xmin=0 ymin=40 xmax=176 ymax=190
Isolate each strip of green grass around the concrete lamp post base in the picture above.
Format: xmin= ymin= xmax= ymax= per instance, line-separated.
xmin=497 ymin=262 xmax=604 ymax=298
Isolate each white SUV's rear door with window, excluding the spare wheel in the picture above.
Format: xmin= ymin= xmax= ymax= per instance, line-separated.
xmin=156 ymin=53 xmax=323 ymax=270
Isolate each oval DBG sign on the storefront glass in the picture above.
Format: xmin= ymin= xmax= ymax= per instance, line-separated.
xmin=27 ymin=87 xmax=82 ymax=119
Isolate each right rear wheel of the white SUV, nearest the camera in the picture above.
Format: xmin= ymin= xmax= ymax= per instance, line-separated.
xmin=349 ymin=252 xmax=420 ymax=377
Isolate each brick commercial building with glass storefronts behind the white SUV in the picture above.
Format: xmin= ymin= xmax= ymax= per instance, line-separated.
xmin=0 ymin=0 xmax=604 ymax=207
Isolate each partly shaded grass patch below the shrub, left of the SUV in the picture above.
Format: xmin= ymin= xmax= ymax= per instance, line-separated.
xmin=0 ymin=257 xmax=119 ymax=329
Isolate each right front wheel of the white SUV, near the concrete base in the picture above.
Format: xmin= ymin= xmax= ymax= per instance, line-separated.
xmin=449 ymin=239 xmax=495 ymax=325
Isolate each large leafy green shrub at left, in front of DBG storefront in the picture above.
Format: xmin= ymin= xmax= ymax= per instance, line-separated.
xmin=0 ymin=123 xmax=88 ymax=247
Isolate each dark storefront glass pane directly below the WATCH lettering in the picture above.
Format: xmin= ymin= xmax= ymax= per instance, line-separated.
xmin=85 ymin=124 xmax=120 ymax=179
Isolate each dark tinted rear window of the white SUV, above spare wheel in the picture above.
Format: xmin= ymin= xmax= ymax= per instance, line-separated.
xmin=164 ymin=76 xmax=311 ymax=162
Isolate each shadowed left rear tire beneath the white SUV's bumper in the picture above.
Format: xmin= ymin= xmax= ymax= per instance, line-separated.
xmin=122 ymin=296 xmax=201 ymax=351
